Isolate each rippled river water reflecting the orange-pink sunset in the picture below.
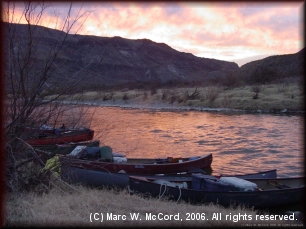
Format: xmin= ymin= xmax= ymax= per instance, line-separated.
xmin=81 ymin=107 xmax=304 ymax=177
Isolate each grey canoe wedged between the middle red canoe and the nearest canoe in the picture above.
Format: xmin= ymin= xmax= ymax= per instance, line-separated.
xmin=61 ymin=164 xmax=277 ymax=188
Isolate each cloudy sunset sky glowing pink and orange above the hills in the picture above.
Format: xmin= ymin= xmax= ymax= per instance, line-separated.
xmin=5 ymin=1 xmax=304 ymax=66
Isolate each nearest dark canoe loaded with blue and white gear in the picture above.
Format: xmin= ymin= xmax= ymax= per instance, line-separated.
xmin=129 ymin=175 xmax=305 ymax=209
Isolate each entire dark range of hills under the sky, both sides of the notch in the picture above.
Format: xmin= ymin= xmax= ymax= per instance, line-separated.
xmin=4 ymin=23 xmax=305 ymax=89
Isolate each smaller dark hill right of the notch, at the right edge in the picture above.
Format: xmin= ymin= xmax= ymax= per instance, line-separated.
xmin=238 ymin=48 xmax=305 ymax=84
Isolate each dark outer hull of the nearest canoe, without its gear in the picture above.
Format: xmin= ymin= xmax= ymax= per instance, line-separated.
xmin=129 ymin=176 xmax=305 ymax=209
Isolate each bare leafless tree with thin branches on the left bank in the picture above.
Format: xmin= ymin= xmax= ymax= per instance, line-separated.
xmin=2 ymin=1 xmax=100 ymax=192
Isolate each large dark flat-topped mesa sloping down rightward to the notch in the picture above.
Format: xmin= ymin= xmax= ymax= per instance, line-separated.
xmin=5 ymin=24 xmax=239 ymax=85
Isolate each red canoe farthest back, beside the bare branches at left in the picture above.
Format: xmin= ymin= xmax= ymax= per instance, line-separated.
xmin=25 ymin=128 xmax=94 ymax=146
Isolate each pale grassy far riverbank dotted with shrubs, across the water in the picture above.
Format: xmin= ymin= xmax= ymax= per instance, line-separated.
xmin=47 ymin=82 xmax=305 ymax=114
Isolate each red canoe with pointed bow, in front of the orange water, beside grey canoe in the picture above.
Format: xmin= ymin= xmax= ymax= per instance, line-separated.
xmin=59 ymin=153 xmax=213 ymax=175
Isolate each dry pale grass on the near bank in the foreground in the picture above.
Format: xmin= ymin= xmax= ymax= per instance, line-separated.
xmin=5 ymin=183 xmax=298 ymax=227
